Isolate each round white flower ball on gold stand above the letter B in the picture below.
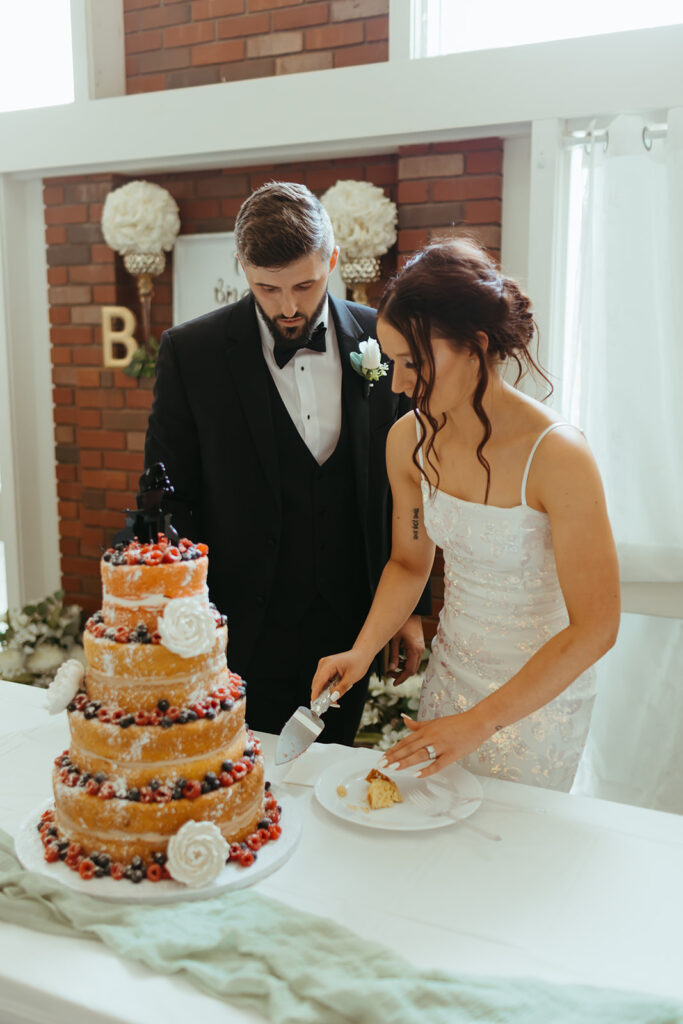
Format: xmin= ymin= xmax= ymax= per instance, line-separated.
xmin=101 ymin=181 xmax=180 ymax=256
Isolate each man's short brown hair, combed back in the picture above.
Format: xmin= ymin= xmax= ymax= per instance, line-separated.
xmin=234 ymin=181 xmax=335 ymax=266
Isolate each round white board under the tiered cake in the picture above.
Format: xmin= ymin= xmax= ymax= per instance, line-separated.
xmin=14 ymin=796 xmax=301 ymax=903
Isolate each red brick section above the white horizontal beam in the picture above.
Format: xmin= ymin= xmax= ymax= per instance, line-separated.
xmin=124 ymin=0 xmax=389 ymax=93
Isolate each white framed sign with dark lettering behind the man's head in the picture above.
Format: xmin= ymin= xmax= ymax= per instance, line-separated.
xmin=173 ymin=231 xmax=346 ymax=324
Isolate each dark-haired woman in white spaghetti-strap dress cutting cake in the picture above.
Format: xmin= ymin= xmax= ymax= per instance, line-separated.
xmin=312 ymin=239 xmax=620 ymax=791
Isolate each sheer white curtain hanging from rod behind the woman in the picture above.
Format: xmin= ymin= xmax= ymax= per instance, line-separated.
xmin=550 ymin=111 xmax=683 ymax=812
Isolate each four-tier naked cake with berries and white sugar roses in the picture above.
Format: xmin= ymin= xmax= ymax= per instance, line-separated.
xmin=38 ymin=517 xmax=281 ymax=887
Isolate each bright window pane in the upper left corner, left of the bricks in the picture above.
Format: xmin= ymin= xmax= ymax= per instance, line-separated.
xmin=0 ymin=0 xmax=74 ymax=114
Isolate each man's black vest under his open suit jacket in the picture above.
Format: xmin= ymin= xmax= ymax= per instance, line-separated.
xmin=268 ymin=374 xmax=370 ymax=627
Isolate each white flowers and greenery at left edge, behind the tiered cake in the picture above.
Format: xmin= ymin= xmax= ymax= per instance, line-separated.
xmin=0 ymin=590 xmax=85 ymax=687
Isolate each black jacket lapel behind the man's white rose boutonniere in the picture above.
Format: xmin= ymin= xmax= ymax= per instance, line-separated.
xmin=330 ymin=295 xmax=370 ymax=541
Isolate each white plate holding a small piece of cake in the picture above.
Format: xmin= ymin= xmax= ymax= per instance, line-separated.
xmin=315 ymin=750 xmax=482 ymax=831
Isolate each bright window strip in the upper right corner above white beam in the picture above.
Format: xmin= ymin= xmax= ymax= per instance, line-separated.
xmin=413 ymin=0 xmax=683 ymax=57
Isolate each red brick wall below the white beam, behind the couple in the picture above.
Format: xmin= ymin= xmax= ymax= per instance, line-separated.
xmin=42 ymin=139 xmax=503 ymax=638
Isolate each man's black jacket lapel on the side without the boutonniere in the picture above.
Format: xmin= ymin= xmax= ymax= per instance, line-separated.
xmin=224 ymin=295 xmax=282 ymax=507
